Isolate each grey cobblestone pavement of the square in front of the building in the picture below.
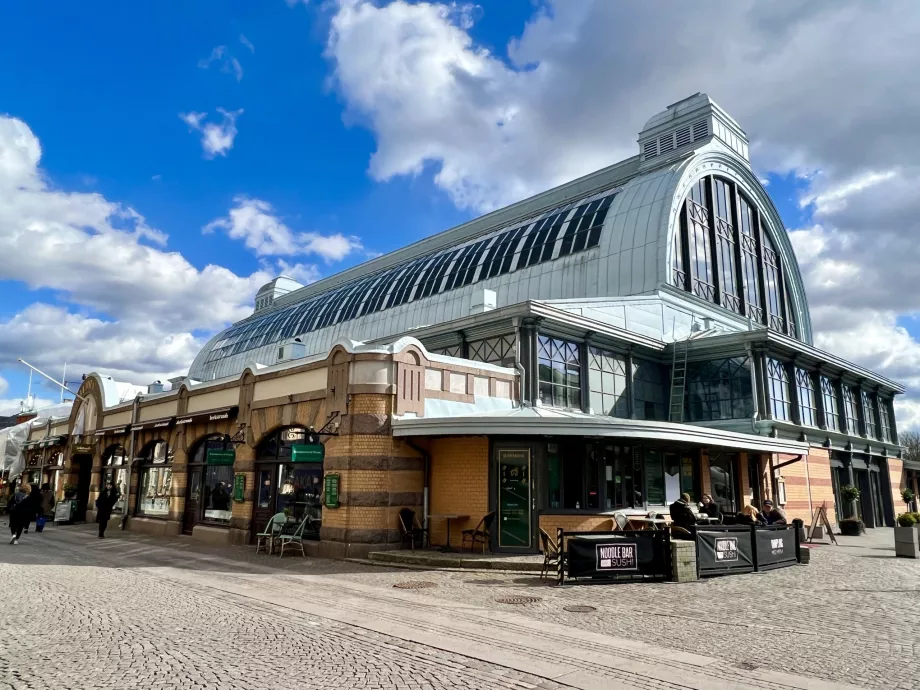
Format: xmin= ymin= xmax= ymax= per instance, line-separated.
xmin=0 ymin=527 xmax=900 ymax=690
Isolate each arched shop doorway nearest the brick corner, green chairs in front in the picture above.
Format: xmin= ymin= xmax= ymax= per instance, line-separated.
xmin=252 ymin=426 xmax=324 ymax=539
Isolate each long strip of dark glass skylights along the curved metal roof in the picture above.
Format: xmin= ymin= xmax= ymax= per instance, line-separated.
xmin=204 ymin=189 xmax=618 ymax=364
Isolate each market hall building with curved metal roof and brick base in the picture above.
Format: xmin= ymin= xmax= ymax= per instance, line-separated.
xmin=55 ymin=94 xmax=904 ymax=556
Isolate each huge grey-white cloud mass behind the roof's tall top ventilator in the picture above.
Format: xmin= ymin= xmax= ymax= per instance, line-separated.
xmin=326 ymin=0 xmax=920 ymax=424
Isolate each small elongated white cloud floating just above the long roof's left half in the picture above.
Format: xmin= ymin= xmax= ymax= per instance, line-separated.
xmin=204 ymin=196 xmax=362 ymax=262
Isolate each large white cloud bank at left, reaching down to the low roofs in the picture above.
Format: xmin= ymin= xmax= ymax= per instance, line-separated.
xmin=0 ymin=116 xmax=274 ymax=383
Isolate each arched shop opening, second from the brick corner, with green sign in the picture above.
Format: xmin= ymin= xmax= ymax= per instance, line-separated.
xmin=182 ymin=434 xmax=236 ymax=534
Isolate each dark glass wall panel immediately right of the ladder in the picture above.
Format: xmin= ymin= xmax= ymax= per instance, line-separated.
xmin=687 ymin=357 xmax=754 ymax=422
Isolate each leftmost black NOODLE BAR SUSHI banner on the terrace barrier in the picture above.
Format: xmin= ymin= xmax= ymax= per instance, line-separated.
xmin=563 ymin=530 xmax=671 ymax=580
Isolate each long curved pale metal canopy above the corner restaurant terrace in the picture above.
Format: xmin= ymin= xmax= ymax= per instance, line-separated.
xmin=393 ymin=407 xmax=809 ymax=455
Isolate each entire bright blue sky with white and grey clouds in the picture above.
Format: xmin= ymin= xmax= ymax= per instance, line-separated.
xmin=0 ymin=0 xmax=920 ymax=420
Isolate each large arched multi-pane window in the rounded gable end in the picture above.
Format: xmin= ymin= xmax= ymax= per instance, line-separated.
xmin=671 ymin=177 xmax=798 ymax=337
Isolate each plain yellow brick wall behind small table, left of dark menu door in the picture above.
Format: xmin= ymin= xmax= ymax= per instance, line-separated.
xmin=429 ymin=436 xmax=494 ymax=546
